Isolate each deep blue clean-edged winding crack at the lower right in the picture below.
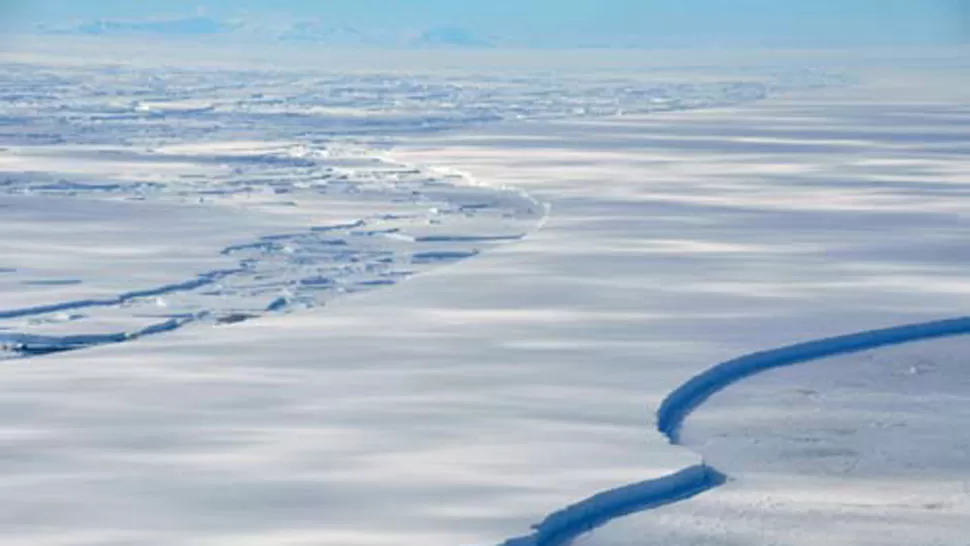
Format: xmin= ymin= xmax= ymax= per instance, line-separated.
xmin=503 ymin=317 xmax=970 ymax=546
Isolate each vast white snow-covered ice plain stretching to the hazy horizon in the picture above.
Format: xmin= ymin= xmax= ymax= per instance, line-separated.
xmin=0 ymin=43 xmax=970 ymax=546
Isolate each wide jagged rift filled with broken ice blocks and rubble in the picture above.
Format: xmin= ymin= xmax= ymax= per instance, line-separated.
xmin=0 ymin=159 xmax=541 ymax=356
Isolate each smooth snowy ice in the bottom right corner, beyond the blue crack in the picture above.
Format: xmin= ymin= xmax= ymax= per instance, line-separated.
xmin=577 ymin=338 xmax=970 ymax=545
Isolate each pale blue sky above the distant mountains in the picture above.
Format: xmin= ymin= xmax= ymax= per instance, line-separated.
xmin=0 ymin=0 xmax=970 ymax=46
